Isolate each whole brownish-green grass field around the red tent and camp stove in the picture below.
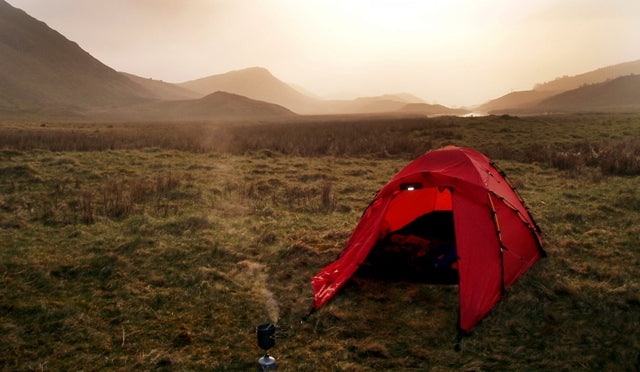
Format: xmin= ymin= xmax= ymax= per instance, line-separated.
xmin=0 ymin=114 xmax=640 ymax=371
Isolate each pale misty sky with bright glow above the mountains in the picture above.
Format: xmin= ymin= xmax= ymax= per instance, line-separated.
xmin=8 ymin=0 xmax=640 ymax=106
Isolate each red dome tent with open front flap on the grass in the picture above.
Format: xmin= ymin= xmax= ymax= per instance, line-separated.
xmin=312 ymin=146 xmax=544 ymax=332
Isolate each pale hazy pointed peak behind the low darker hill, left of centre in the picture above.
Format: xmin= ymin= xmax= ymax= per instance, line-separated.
xmin=178 ymin=67 xmax=323 ymax=114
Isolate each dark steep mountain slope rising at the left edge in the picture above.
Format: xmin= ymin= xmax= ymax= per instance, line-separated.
xmin=0 ymin=0 xmax=150 ymax=110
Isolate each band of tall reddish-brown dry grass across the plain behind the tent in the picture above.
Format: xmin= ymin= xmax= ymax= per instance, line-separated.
xmin=0 ymin=113 xmax=640 ymax=175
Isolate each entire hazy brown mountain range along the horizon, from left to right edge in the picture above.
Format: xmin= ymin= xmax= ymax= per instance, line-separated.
xmin=0 ymin=0 xmax=640 ymax=120
